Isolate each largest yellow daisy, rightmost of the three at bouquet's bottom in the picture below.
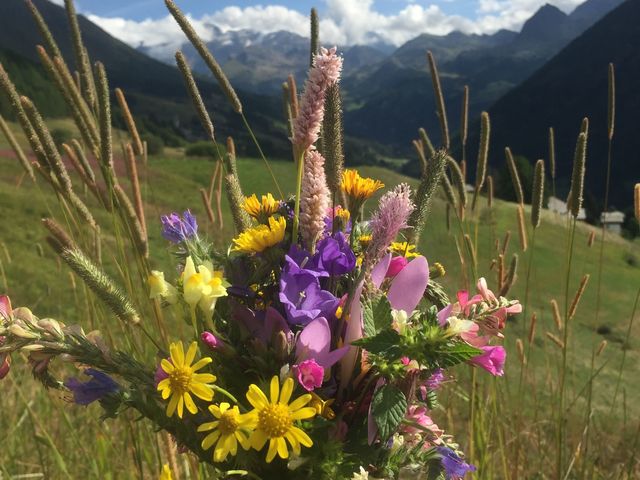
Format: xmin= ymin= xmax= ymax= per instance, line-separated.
xmin=247 ymin=375 xmax=316 ymax=463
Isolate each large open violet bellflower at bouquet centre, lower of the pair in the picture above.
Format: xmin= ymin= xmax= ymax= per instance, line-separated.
xmin=279 ymin=255 xmax=339 ymax=325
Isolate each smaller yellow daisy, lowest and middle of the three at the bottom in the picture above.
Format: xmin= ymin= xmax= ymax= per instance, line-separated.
xmin=198 ymin=402 xmax=255 ymax=462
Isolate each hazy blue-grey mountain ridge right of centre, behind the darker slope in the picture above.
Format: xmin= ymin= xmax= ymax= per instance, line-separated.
xmin=343 ymin=0 xmax=622 ymax=153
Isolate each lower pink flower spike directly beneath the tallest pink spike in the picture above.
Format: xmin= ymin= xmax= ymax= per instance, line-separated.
xmin=300 ymin=150 xmax=331 ymax=252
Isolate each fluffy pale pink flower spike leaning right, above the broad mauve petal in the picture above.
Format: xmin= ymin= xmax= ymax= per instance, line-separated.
xmin=364 ymin=183 xmax=416 ymax=269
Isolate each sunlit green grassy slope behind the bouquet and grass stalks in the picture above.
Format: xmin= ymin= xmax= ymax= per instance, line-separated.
xmin=0 ymin=126 xmax=640 ymax=472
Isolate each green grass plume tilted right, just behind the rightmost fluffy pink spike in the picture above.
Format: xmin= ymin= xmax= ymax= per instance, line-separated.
xmin=408 ymin=149 xmax=447 ymax=245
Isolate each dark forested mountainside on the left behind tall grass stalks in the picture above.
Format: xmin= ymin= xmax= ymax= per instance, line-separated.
xmin=0 ymin=0 xmax=289 ymax=155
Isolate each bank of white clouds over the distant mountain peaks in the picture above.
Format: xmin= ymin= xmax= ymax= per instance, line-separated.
xmin=85 ymin=0 xmax=584 ymax=56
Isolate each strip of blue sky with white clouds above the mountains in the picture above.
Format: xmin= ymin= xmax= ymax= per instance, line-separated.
xmin=51 ymin=0 xmax=584 ymax=50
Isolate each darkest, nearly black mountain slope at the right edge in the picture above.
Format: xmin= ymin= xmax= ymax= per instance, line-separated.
xmin=480 ymin=0 xmax=640 ymax=207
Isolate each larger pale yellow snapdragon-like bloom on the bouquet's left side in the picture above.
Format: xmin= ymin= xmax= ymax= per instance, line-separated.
xmin=182 ymin=257 xmax=229 ymax=314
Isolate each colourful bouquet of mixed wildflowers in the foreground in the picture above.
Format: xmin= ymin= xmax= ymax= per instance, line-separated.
xmin=0 ymin=2 xmax=520 ymax=479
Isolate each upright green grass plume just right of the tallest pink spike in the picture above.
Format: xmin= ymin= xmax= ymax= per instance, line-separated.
xmin=322 ymin=83 xmax=344 ymax=203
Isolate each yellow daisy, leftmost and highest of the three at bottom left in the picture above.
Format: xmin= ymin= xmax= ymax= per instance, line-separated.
xmin=158 ymin=342 xmax=216 ymax=418
